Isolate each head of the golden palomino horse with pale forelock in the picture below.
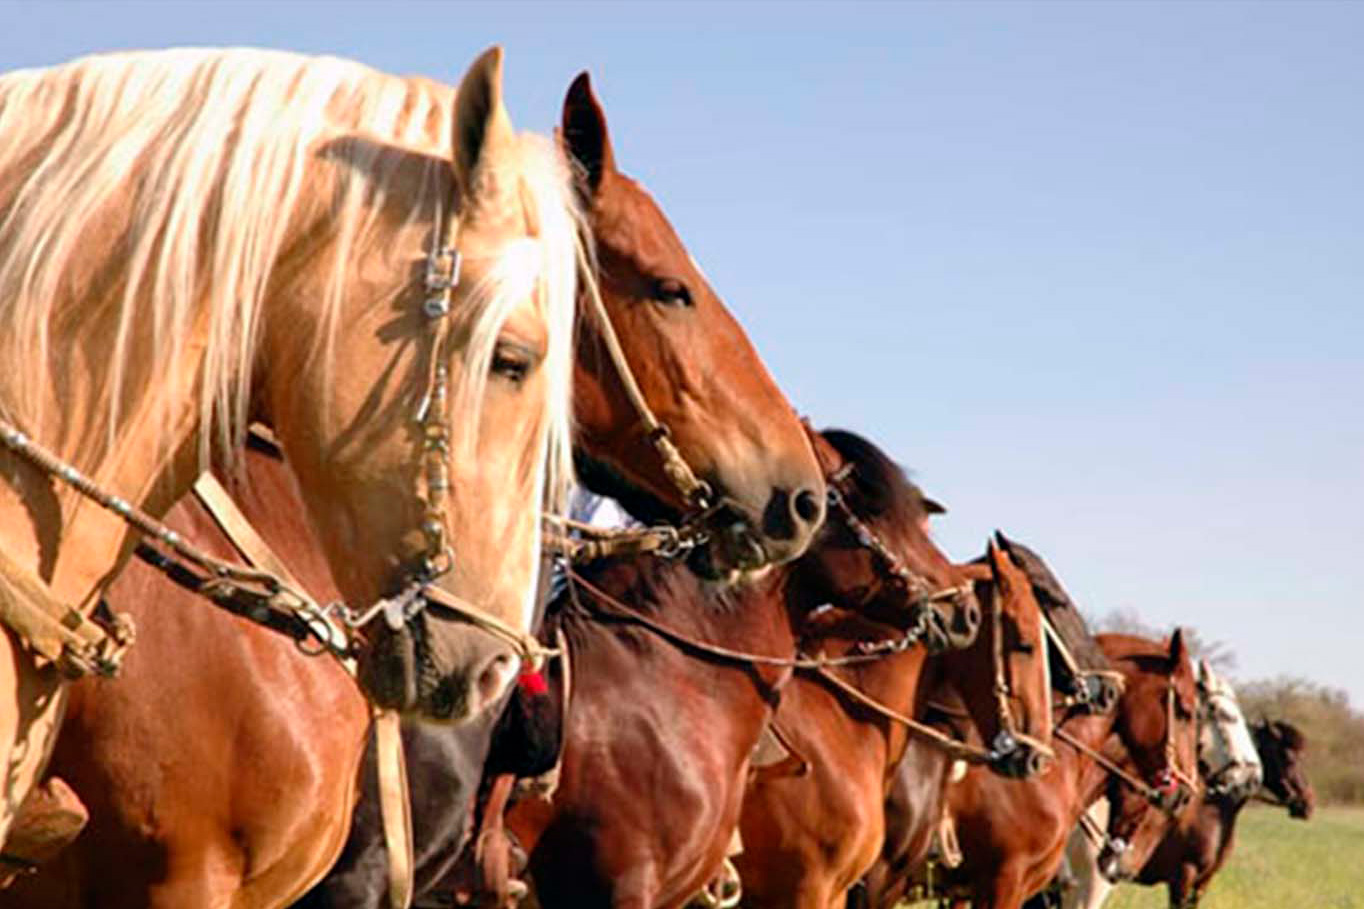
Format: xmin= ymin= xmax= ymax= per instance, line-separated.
xmin=258 ymin=48 xmax=587 ymax=721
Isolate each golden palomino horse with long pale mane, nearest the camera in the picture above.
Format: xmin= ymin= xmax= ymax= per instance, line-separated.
xmin=0 ymin=49 xmax=585 ymax=834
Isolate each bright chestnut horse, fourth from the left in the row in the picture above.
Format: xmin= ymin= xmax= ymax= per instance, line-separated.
xmin=735 ymin=540 xmax=1052 ymax=909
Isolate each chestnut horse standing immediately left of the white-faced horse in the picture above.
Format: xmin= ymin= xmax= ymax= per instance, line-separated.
xmin=872 ymin=631 xmax=1196 ymax=909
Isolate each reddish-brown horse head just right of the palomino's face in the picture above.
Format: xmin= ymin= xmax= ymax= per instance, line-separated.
xmin=562 ymin=72 xmax=824 ymax=579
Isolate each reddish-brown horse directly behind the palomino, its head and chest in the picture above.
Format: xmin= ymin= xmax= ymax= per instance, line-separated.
xmin=0 ymin=79 xmax=822 ymax=908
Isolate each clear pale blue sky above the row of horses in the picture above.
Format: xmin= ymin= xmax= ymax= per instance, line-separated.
xmin=0 ymin=1 xmax=1364 ymax=706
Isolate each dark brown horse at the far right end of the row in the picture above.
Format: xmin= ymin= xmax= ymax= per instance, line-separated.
xmin=1061 ymin=707 xmax=1315 ymax=909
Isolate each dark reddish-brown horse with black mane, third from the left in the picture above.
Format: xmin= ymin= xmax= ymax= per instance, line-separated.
xmin=507 ymin=433 xmax=978 ymax=909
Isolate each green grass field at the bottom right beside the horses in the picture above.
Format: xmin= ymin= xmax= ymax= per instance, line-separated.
xmin=1105 ymin=808 xmax=1364 ymax=909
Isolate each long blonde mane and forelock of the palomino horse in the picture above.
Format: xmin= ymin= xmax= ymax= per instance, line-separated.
xmin=0 ymin=49 xmax=581 ymax=508
